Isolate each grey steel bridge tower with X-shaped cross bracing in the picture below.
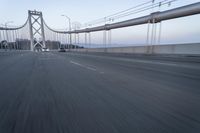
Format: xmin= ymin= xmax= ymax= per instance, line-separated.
xmin=28 ymin=10 xmax=46 ymax=51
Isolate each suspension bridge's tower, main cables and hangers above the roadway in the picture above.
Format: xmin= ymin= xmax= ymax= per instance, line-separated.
xmin=0 ymin=3 xmax=200 ymax=53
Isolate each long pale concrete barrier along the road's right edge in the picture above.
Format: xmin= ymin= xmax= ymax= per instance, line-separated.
xmin=74 ymin=43 xmax=200 ymax=55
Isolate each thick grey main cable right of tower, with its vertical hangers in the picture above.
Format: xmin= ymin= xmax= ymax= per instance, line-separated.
xmin=39 ymin=0 xmax=200 ymax=50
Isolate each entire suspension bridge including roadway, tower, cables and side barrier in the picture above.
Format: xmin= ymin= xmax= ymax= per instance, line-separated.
xmin=0 ymin=1 xmax=200 ymax=133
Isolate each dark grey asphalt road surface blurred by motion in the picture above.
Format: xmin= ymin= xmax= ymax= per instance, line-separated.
xmin=0 ymin=52 xmax=200 ymax=133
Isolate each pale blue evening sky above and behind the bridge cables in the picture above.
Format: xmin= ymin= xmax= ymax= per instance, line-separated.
xmin=0 ymin=0 xmax=200 ymax=44
